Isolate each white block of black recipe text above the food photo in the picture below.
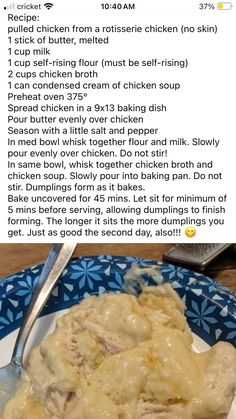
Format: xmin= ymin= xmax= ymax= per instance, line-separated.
xmin=1 ymin=1 xmax=236 ymax=242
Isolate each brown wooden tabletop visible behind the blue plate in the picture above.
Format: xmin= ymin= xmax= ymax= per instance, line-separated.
xmin=0 ymin=243 xmax=236 ymax=293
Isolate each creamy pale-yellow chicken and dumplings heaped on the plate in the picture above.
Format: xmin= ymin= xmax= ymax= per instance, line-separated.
xmin=2 ymin=284 xmax=236 ymax=419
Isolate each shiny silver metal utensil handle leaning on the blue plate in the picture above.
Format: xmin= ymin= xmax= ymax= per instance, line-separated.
xmin=11 ymin=243 xmax=76 ymax=370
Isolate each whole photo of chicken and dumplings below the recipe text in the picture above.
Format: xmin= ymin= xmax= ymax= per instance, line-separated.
xmin=0 ymin=243 xmax=236 ymax=419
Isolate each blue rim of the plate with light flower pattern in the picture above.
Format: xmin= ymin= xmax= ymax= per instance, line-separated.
xmin=0 ymin=255 xmax=236 ymax=346
